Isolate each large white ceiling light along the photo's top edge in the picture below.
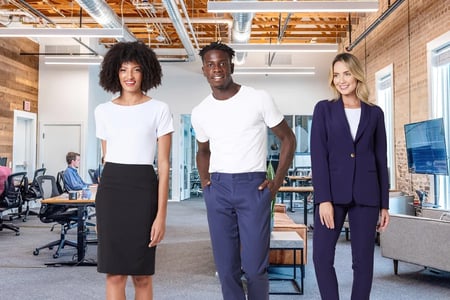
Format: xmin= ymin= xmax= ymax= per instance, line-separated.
xmin=207 ymin=0 xmax=378 ymax=13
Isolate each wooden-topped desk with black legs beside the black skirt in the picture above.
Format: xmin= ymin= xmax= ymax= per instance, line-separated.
xmin=41 ymin=192 xmax=97 ymax=266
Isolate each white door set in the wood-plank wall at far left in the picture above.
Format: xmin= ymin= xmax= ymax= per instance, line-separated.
xmin=11 ymin=110 xmax=36 ymax=178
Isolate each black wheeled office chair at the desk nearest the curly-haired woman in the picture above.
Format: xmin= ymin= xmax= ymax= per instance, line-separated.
xmin=33 ymin=175 xmax=77 ymax=258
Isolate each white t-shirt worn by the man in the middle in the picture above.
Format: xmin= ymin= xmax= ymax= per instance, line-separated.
xmin=191 ymin=86 xmax=284 ymax=173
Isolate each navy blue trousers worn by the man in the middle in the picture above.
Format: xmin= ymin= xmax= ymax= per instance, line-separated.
xmin=203 ymin=172 xmax=271 ymax=300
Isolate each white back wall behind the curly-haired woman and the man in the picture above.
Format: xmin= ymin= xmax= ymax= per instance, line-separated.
xmin=38 ymin=49 xmax=335 ymax=199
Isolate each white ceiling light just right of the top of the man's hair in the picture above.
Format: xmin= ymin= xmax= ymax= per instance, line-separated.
xmin=229 ymin=44 xmax=338 ymax=52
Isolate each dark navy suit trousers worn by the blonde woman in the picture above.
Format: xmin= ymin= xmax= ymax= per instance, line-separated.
xmin=313 ymin=204 xmax=380 ymax=300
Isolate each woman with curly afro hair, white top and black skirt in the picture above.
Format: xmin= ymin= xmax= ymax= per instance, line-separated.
xmin=95 ymin=42 xmax=173 ymax=299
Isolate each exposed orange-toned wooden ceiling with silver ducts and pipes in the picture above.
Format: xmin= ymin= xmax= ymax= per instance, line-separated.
xmin=0 ymin=0 xmax=370 ymax=65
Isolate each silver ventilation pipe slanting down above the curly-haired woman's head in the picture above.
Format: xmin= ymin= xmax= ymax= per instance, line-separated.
xmin=76 ymin=0 xmax=136 ymax=42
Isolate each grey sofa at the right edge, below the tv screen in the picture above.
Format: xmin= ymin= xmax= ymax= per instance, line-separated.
xmin=380 ymin=208 xmax=450 ymax=274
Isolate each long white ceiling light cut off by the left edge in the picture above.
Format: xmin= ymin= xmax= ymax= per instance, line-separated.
xmin=0 ymin=27 xmax=123 ymax=38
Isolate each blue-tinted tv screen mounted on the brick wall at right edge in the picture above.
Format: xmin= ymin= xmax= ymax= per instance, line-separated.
xmin=404 ymin=118 xmax=448 ymax=175
